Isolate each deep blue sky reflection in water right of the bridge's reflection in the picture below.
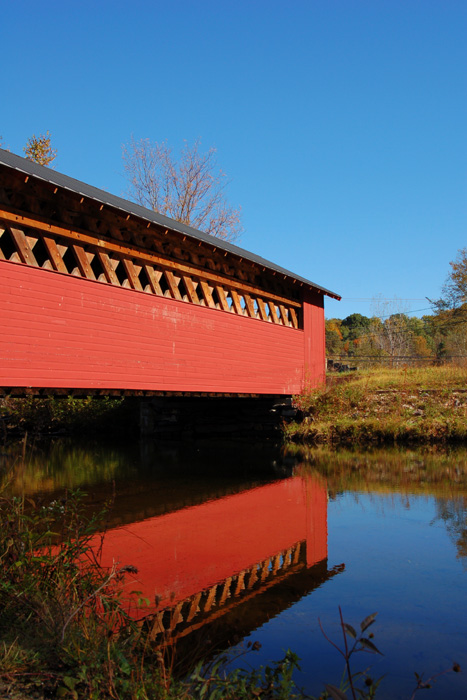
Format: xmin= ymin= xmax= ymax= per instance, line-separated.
xmin=238 ymin=493 xmax=467 ymax=700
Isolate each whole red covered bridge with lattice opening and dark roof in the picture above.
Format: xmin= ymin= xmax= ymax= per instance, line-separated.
xmin=0 ymin=150 xmax=339 ymax=395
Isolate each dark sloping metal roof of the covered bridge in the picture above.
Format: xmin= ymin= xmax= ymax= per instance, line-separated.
xmin=0 ymin=149 xmax=341 ymax=300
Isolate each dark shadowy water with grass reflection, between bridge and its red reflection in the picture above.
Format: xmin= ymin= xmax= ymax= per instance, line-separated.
xmin=0 ymin=438 xmax=297 ymax=522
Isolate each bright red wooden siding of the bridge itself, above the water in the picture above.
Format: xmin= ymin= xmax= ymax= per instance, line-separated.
xmin=0 ymin=261 xmax=324 ymax=394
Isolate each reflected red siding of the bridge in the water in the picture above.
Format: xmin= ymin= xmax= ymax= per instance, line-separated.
xmin=98 ymin=476 xmax=327 ymax=613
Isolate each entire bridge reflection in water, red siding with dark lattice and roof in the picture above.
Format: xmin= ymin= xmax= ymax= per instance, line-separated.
xmin=97 ymin=475 xmax=340 ymax=642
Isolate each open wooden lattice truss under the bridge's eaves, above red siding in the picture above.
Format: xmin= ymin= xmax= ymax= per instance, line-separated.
xmin=0 ymin=173 xmax=308 ymax=329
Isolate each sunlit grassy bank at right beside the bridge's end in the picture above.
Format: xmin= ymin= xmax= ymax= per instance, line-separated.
xmin=284 ymin=365 xmax=467 ymax=444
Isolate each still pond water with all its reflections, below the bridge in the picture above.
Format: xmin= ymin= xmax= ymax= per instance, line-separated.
xmin=0 ymin=441 xmax=467 ymax=700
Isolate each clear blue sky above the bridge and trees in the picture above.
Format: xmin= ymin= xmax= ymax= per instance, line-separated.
xmin=0 ymin=0 xmax=467 ymax=318
